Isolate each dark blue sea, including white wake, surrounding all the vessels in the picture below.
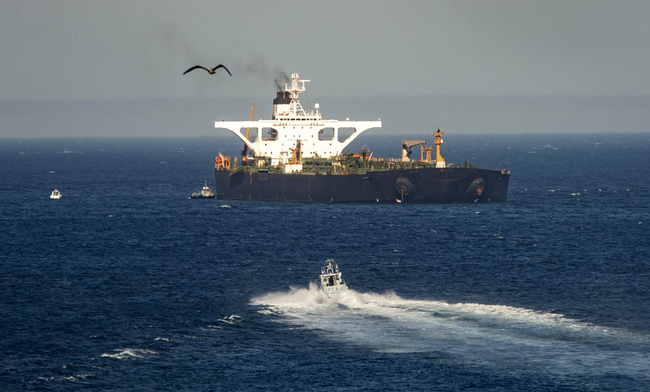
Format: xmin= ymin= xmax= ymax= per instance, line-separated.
xmin=0 ymin=134 xmax=650 ymax=391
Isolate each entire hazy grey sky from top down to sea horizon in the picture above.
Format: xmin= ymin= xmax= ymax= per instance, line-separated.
xmin=0 ymin=0 xmax=650 ymax=137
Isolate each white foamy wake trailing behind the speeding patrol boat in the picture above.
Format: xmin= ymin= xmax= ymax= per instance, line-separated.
xmin=251 ymin=284 xmax=650 ymax=380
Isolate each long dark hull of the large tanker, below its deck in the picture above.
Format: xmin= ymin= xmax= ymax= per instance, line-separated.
xmin=215 ymin=168 xmax=510 ymax=203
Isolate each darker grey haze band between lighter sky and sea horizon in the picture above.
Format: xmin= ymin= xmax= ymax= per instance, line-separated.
xmin=0 ymin=95 xmax=650 ymax=138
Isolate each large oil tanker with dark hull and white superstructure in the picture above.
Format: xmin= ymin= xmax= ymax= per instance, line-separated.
xmin=214 ymin=73 xmax=510 ymax=203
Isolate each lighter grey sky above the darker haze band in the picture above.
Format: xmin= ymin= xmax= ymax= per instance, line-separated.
xmin=0 ymin=0 xmax=650 ymax=137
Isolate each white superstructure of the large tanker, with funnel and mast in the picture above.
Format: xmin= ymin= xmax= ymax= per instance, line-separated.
xmin=214 ymin=72 xmax=381 ymax=168
